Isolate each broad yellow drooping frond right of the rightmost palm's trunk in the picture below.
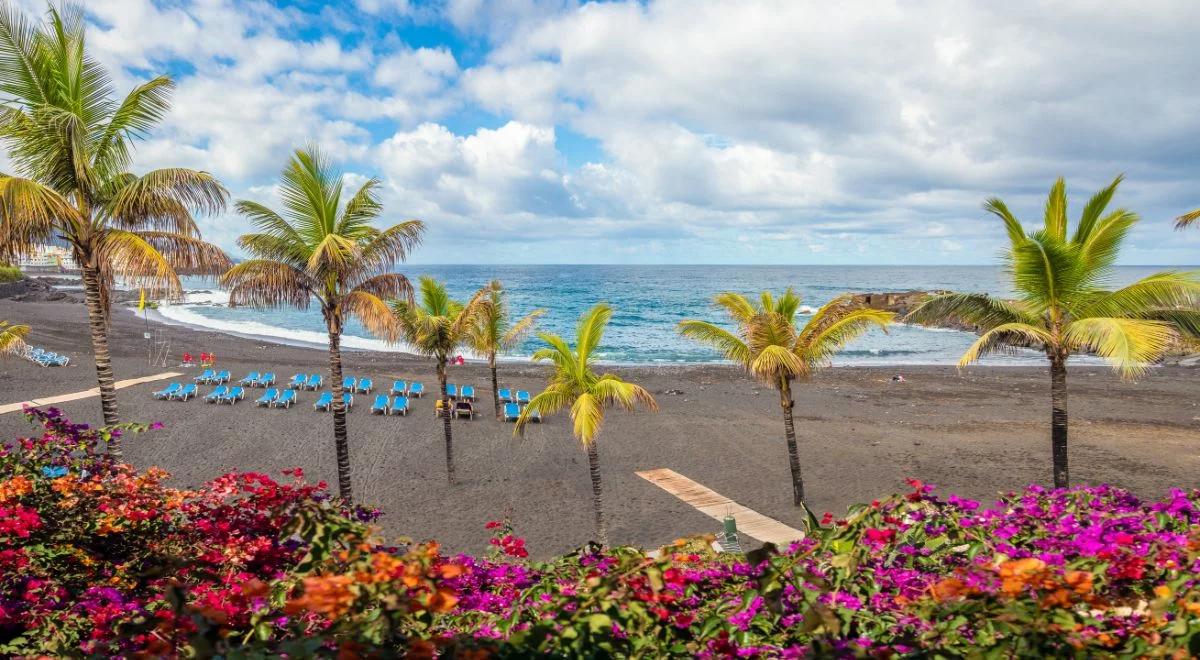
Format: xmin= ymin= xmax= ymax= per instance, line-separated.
xmin=1063 ymin=317 xmax=1178 ymax=378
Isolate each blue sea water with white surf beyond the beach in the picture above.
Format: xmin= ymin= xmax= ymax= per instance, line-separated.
xmin=160 ymin=265 xmax=1190 ymax=365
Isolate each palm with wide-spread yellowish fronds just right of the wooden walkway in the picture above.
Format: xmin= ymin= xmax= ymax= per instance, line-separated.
xmin=679 ymin=288 xmax=895 ymax=506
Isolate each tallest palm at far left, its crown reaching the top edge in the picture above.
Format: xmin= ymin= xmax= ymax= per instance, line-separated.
xmin=0 ymin=2 xmax=229 ymax=444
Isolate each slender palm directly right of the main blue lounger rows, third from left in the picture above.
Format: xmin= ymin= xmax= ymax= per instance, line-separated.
xmin=392 ymin=276 xmax=485 ymax=485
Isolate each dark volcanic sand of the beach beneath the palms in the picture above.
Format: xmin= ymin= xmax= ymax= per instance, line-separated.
xmin=0 ymin=300 xmax=1200 ymax=556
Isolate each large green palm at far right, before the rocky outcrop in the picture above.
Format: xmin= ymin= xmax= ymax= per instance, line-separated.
xmin=907 ymin=176 xmax=1200 ymax=488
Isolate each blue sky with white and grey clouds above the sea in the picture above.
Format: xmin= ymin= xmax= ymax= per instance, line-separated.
xmin=17 ymin=0 xmax=1200 ymax=264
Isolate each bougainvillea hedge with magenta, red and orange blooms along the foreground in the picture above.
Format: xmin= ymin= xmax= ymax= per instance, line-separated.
xmin=0 ymin=410 xmax=1200 ymax=658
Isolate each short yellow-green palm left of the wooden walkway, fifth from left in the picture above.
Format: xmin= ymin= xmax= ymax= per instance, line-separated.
xmin=514 ymin=302 xmax=659 ymax=546
